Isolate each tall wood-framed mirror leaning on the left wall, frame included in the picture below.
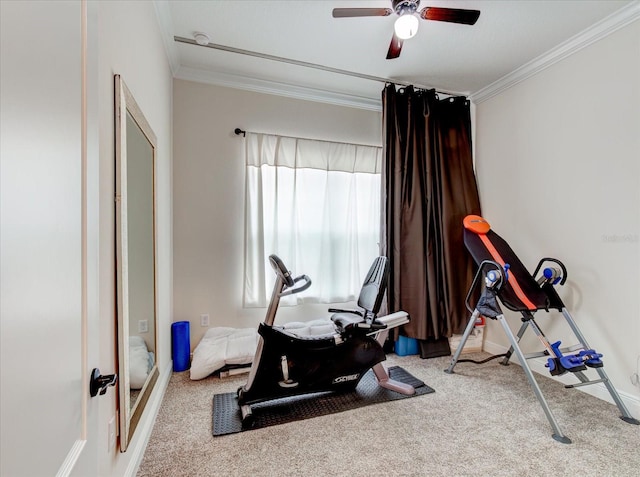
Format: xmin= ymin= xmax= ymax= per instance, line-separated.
xmin=115 ymin=75 xmax=159 ymax=452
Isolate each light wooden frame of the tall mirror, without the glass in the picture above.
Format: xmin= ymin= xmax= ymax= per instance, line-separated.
xmin=114 ymin=75 xmax=159 ymax=452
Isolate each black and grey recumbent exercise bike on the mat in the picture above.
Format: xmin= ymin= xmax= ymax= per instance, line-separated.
xmin=237 ymin=255 xmax=415 ymax=427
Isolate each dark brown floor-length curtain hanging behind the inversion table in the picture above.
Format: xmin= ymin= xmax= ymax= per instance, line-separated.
xmin=381 ymin=84 xmax=480 ymax=358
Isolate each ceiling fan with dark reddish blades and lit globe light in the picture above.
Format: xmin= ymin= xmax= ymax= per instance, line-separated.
xmin=333 ymin=0 xmax=480 ymax=60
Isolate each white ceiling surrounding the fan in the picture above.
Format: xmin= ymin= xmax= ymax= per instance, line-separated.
xmin=155 ymin=0 xmax=640 ymax=108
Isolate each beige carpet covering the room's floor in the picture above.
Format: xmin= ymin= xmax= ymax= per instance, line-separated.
xmin=137 ymin=354 xmax=640 ymax=477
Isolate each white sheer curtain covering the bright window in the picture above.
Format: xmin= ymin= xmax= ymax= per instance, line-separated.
xmin=244 ymin=133 xmax=382 ymax=307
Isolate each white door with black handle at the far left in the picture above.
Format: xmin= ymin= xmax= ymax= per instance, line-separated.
xmin=0 ymin=1 xmax=98 ymax=477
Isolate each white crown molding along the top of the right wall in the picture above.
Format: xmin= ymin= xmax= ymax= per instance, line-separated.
xmin=470 ymin=1 xmax=640 ymax=104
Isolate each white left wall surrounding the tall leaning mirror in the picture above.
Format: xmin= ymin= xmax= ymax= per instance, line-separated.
xmin=97 ymin=1 xmax=173 ymax=475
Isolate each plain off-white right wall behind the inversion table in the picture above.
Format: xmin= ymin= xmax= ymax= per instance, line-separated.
xmin=476 ymin=21 xmax=640 ymax=410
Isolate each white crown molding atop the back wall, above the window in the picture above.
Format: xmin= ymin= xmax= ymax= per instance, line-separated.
xmin=173 ymin=66 xmax=382 ymax=111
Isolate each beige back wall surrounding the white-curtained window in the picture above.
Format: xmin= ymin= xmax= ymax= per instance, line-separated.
xmin=173 ymin=80 xmax=382 ymax=349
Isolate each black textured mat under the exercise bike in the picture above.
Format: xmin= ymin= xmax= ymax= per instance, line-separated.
xmin=213 ymin=366 xmax=435 ymax=436
